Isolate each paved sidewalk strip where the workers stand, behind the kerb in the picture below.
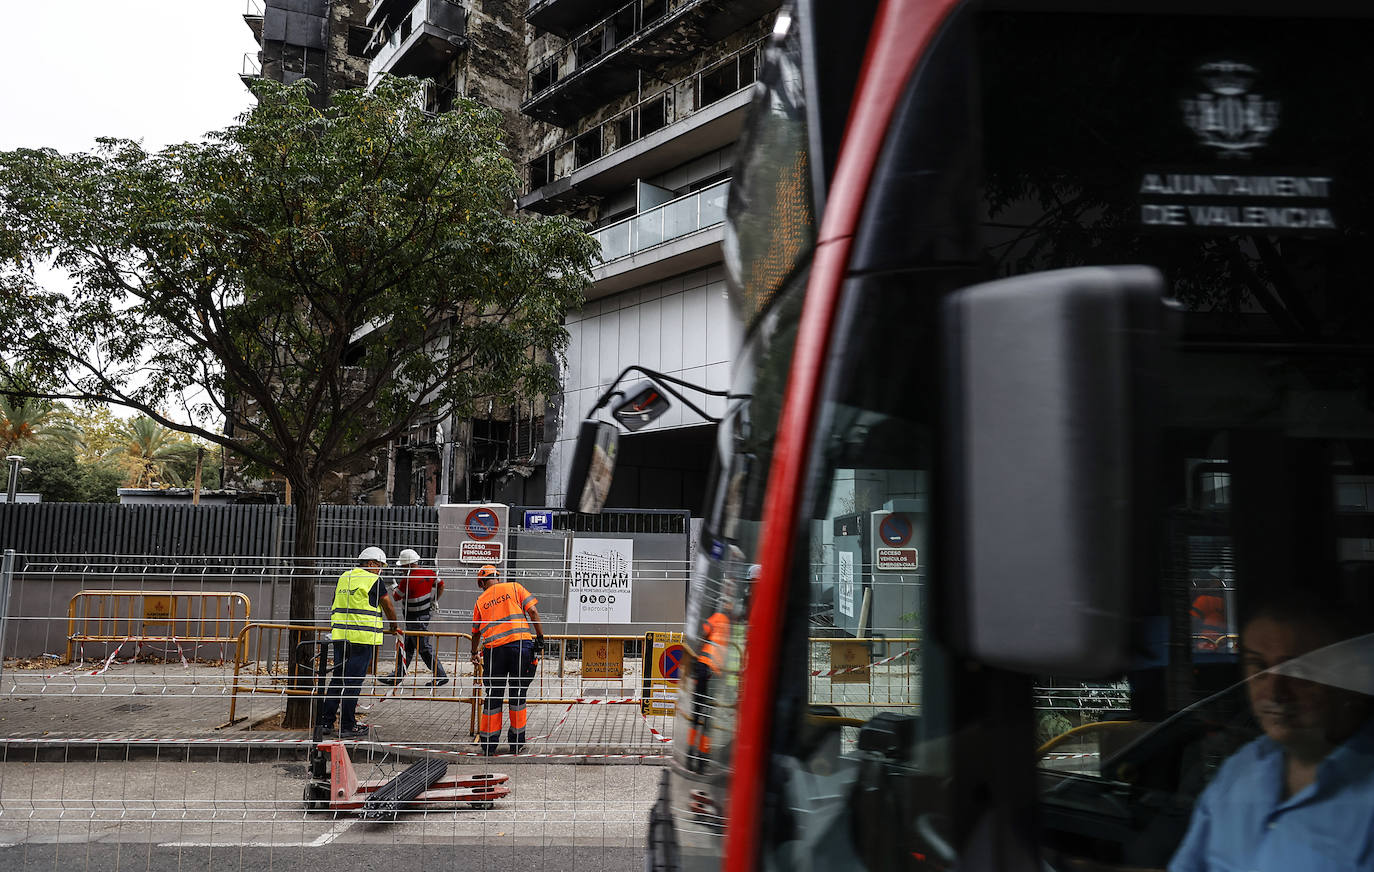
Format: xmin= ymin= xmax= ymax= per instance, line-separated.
xmin=0 ymin=661 xmax=673 ymax=762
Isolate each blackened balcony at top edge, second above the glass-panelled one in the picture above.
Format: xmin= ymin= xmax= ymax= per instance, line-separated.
xmin=521 ymin=0 xmax=779 ymax=128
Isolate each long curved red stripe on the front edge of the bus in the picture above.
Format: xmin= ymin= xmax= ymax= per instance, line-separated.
xmin=723 ymin=0 xmax=959 ymax=872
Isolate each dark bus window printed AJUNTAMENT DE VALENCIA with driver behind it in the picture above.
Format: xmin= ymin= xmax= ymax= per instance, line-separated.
xmin=976 ymin=11 xmax=1374 ymax=869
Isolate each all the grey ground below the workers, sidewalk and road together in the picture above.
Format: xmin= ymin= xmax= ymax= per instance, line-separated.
xmin=0 ymin=661 xmax=672 ymax=872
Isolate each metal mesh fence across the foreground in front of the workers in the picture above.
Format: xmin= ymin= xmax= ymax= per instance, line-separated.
xmin=0 ymin=546 xmax=676 ymax=869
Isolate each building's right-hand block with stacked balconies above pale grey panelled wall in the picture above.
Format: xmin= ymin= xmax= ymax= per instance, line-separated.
xmin=519 ymin=0 xmax=779 ymax=514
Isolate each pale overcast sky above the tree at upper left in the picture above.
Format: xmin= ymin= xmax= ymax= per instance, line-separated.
xmin=0 ymin=0 xmax=257 ymax=151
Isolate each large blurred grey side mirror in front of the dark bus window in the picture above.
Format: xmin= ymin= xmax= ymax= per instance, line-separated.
xmin=941 ymin=266 xmax=1169 ymax=677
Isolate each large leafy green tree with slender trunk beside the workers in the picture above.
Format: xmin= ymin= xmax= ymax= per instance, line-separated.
xmin=0 ymin=78 xmax=596 ymax=725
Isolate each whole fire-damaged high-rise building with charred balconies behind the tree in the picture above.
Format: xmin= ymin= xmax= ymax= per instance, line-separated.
xmin=250 ymin=0 xmax=779 ymax=515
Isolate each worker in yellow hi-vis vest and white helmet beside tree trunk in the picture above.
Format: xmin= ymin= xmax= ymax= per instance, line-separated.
xmin=317 ymin=548 xmax=404 ymax=739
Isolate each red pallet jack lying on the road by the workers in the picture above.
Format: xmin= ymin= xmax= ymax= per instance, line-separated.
xmin=297 ymin=640 xmax=511 ymax=820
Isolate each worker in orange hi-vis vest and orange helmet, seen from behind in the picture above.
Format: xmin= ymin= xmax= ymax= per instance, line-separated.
xmin=473 ymin=564 xmax=544 ymax=754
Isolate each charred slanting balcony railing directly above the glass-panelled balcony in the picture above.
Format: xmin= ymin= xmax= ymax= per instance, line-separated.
xmin=528 ymin=40 xmax=767 ymax=191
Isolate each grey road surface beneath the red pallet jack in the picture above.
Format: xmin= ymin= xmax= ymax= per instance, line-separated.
xmin=0 ymin=761 xmax=662 ymax=872
